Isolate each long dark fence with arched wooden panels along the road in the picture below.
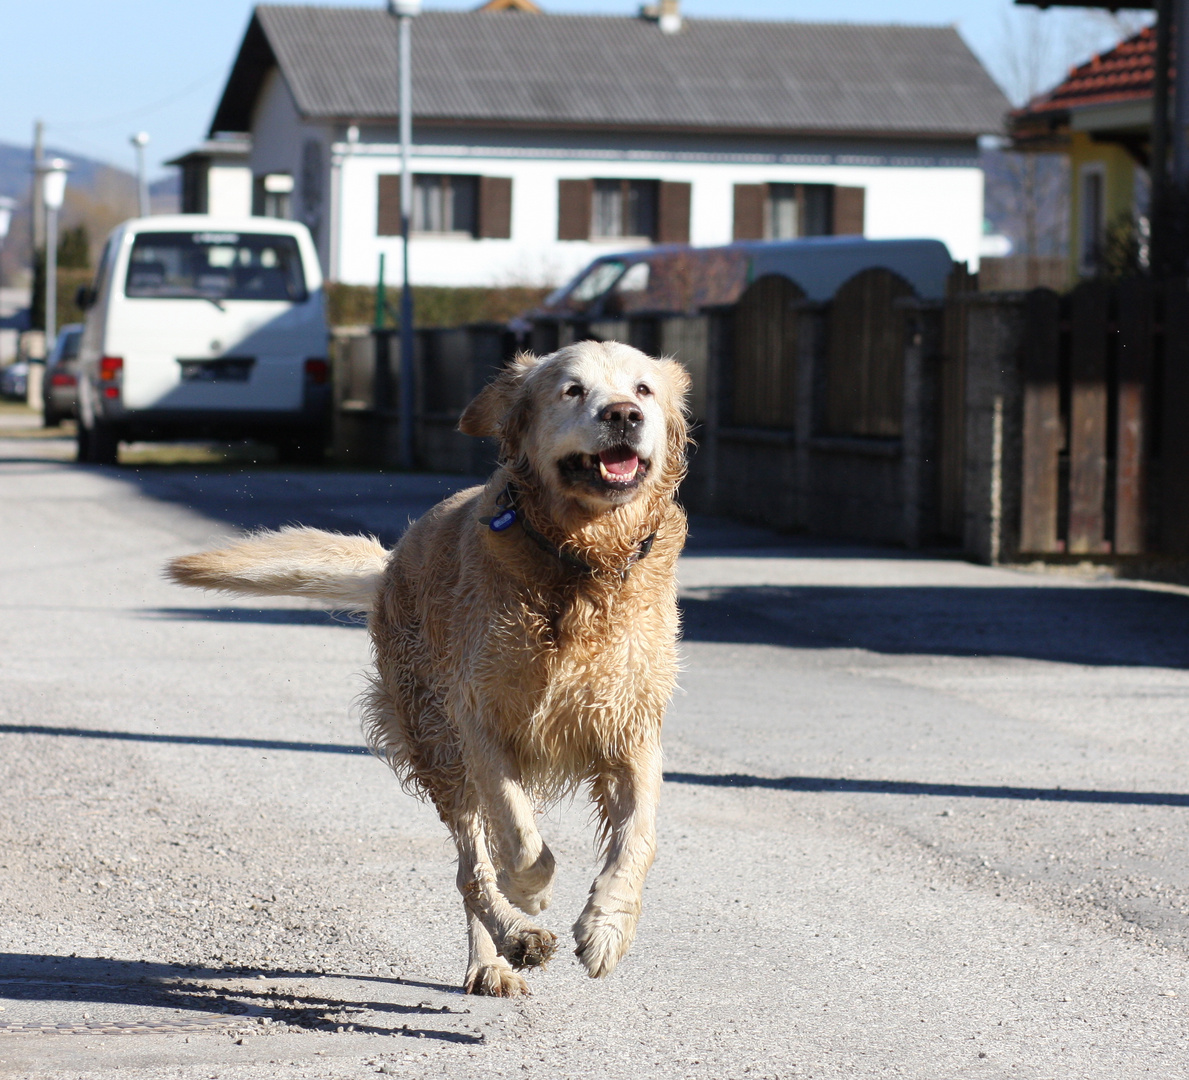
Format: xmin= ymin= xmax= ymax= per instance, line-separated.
xmin=335 ymin=268 xmax=1189 ymax=561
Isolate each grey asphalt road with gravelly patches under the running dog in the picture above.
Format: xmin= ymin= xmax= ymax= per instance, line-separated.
xmin=0 ymin=425 xmax=1189 ymax=1080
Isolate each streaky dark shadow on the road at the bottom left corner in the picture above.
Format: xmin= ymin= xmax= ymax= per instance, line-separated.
xmin=0 ymin=953 xmax=483 ymax=1043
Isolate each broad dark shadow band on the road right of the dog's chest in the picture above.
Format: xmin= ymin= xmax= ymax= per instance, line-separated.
xmin=681 ymin=585 xmax=1189 ymax=668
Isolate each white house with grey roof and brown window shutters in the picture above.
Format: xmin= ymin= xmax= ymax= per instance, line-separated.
xmin=183 ymin=0 xmax=1008 ymax=285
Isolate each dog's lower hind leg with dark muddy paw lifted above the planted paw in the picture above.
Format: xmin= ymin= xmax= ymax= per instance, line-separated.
xmin=454 ymin=810 xmax=558 ymax=968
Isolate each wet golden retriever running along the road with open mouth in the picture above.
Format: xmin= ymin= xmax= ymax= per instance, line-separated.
xmin=168 ymin=341 xmax=690 ymax=996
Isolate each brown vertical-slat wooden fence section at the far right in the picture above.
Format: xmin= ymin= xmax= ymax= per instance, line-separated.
xmin=1019 ymin=281 xmax=1189 ymax=555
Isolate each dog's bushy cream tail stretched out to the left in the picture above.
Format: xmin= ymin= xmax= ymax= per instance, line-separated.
xmin=165 ymin=528 xmax=389 ymax=611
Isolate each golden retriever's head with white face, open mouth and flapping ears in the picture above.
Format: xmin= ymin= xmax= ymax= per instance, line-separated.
xmin=459 ymin=341 xmax=690 ymax=511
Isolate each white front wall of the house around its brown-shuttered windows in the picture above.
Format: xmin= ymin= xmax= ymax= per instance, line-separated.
xmin=323 ymin=130 xmax=983 ymax=285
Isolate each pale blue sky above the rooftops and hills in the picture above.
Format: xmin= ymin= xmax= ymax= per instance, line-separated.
xmin=0 ymin=0 xmax=1150 ymax=176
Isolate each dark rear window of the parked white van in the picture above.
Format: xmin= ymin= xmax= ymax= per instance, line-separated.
xmin=124 ymin=232 xmax=307 ymax=303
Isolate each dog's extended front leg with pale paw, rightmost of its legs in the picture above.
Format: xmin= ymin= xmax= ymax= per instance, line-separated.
xmin=574 ymin=742 xmax=661 ymax=979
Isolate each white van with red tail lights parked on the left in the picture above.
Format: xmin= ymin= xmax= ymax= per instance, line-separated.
xmin=77 ymin=214 xmax=331 ymax=464
